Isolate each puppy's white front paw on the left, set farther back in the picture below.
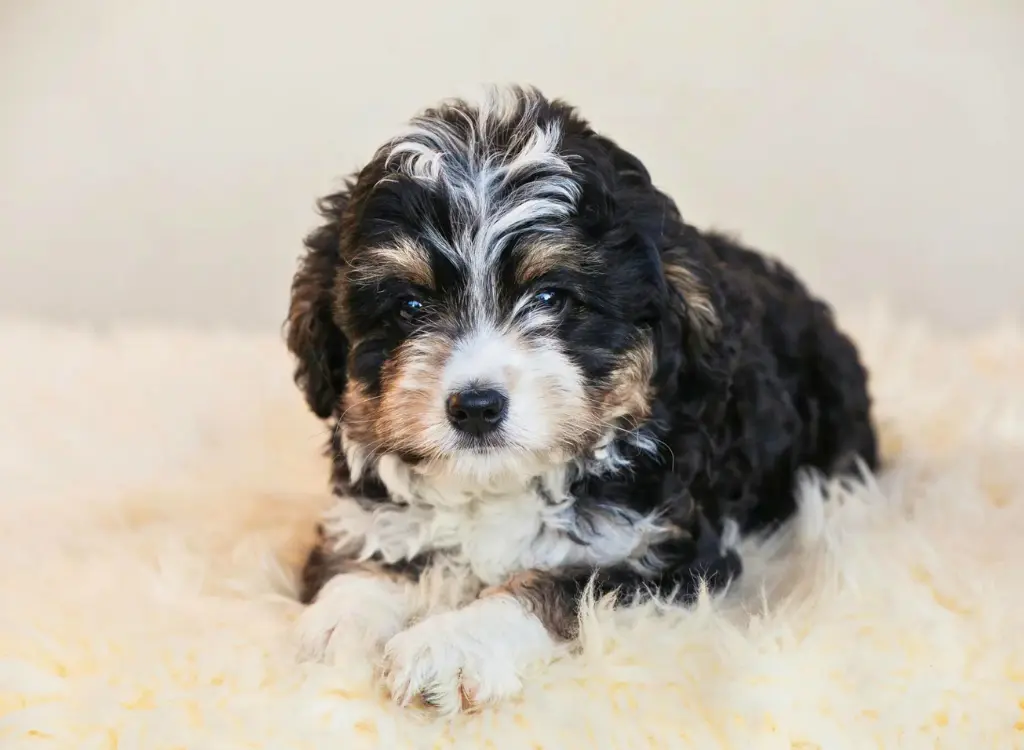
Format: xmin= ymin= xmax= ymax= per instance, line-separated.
xmin=296 ymin=574 xmax=409 ymax=663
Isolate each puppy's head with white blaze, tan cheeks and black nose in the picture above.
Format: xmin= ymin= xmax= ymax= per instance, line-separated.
xmin=288 ymin=88 xmax=714 ymax=483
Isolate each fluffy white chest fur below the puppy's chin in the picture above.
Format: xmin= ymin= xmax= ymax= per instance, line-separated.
xmin=325 ymin=448 xmax=666 ymax=585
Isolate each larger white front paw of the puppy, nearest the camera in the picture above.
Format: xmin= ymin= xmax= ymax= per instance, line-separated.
xmin=384 ymin=594 xmax=559 ymax=714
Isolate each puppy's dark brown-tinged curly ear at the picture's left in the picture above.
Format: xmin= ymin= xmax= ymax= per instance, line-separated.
xmin=286 ymin=191 xmax=348 ymax=419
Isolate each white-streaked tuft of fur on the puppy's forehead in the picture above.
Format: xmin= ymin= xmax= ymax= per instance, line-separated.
xmin=384 ymin=87 xmax=580 ymax=278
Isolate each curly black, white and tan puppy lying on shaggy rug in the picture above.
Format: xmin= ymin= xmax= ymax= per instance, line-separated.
xmin=287 ymin=88 xmax=878 ymax=712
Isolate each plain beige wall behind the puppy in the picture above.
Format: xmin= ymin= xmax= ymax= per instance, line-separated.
xmin=0 ymin=0 xmax=1024 ymax=334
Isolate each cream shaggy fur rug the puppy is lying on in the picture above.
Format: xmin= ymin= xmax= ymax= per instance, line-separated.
xmin=0 ymin=314 xmax=1024 ymax=750
